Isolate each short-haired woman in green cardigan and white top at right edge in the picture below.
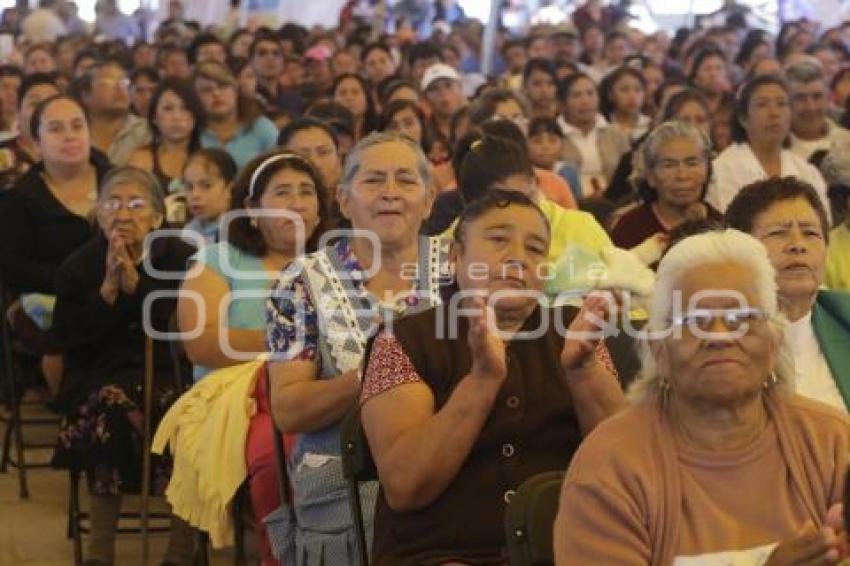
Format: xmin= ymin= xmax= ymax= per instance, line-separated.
xmin=726 ymin=177 xmax=850 ymax=412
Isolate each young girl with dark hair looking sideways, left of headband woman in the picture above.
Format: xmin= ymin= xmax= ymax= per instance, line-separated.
xmin=183 ymin=148 xmax=237 ymax=244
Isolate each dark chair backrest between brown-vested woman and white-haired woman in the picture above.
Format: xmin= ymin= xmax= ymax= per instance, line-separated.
xmin=505 ymin=471 xmax=564 ymax=566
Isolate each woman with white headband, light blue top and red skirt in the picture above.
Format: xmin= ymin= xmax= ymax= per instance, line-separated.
xmin=178 ymin=150 xmax=328 ymax=564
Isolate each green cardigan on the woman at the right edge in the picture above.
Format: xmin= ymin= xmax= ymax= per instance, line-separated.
xmin=812 ymin=291 xmax=850 ymax=409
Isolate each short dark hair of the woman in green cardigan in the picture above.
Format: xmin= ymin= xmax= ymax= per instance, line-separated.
xmin=726 ymin=176 xmax=829 ymax=239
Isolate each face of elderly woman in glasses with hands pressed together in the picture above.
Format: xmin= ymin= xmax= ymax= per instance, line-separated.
xmin=97 ymin=183 xmax=163 ymax=247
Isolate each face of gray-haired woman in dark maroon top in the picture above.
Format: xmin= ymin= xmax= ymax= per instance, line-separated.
xmin=647 ymin=138 xmax=708 ymax=209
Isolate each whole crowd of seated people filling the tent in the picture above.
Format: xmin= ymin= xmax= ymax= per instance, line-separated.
xmin=0 ymin=0 xmax=850 ymax=566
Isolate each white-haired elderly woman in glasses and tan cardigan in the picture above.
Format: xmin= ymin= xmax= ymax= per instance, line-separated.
xmin=554 ymin=230 xmax=850 ymax=566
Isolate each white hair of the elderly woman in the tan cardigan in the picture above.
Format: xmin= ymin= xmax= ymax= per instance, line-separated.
xmin=628 ymin=229 xmax=794 ymax=401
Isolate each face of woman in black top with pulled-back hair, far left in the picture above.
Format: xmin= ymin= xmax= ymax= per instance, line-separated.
xmin=38 ymin=98 xmax=91 ymax=166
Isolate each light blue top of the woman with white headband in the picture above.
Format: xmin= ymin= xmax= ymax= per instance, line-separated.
xmin=189 ymin=242 xmax=277 ymax=381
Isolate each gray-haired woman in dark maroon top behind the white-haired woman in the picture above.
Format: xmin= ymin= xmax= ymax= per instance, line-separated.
xmin=611 ymin=122 xmax=722 ymax=264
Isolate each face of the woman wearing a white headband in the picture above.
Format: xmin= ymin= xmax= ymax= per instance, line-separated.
xmin=252 ymin=167 xmax=319 ymax=255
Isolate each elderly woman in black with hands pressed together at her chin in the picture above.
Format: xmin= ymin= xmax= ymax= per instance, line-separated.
xmin=53 ymin=166 xmax=194 ymax=566
